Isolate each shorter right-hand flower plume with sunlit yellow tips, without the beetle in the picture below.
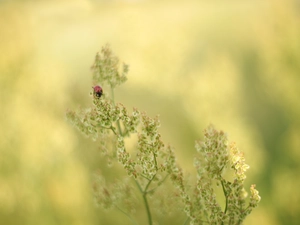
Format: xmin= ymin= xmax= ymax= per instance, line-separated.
xmin=195 ymin=125 xmax=260 ymax=224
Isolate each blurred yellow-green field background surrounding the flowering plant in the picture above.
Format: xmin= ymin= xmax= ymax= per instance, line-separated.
xmin=0 ymin=0 xmax=300 ymax=225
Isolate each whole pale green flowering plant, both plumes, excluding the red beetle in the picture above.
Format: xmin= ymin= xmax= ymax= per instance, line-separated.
xmin=67 ymin=46 xmax=260 ymax=225
